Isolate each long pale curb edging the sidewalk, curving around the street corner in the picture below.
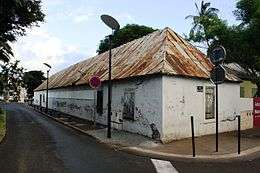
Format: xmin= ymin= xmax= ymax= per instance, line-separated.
xmin=26 ymin=106 xmax=260 ymax=163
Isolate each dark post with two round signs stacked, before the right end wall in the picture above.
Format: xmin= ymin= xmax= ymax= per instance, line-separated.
xmin=210 ymin=46 xmax=226 ymax=152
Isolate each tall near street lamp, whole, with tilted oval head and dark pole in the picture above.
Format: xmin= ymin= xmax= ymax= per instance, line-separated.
xmin=101 ymin=15 xmax=120 ymax=138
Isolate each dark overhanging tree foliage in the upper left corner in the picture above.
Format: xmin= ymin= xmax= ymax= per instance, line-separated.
xmin=0 ymin=0 xmax=44 ymax=61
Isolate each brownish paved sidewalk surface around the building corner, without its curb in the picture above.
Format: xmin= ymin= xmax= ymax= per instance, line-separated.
xmin=86 ymin=129 xmax=260 ymax=158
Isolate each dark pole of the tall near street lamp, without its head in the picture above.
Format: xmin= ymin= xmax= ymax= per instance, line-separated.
xmin=107 ymin=35 xmax=112 ymax=138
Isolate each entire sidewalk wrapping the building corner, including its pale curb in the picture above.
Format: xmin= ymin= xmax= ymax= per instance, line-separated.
xmin=29 ymin=105 xmax=260 ymax=160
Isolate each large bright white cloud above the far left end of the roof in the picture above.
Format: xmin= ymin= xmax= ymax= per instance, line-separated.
xmin=12 ymin=28 xmax=79 ymax=72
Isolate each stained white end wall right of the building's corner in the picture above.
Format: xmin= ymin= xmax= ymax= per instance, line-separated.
xmin=162 ymin=76 xmax=252 ymax=142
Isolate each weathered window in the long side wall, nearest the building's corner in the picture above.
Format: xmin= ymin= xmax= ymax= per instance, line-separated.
xmin=123 ymin=90 xmax=135 ymax=120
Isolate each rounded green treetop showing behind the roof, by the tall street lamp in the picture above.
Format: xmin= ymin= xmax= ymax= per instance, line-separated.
xmin=97 ymin=24 xmax=155 ymax=54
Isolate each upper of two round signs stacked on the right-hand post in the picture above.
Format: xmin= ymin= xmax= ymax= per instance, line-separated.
xmin=210 ymin=46 xmax=226 ymax=65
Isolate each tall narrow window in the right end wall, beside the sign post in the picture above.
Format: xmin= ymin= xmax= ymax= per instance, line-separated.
xmin=205 ymin=86 xmax=215 ymax=120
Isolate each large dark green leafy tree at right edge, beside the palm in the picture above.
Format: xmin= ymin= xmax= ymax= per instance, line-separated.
xmin=225 ymin=0 xmax=260 ymax=96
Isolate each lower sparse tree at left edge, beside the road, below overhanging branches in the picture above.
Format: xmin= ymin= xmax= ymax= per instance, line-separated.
xmin=1 ymin=61 xmax=24 ymax=101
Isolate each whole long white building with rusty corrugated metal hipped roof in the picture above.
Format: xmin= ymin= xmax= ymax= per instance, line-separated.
xmin=34 ymin=28 xmax=252 ymax=142
